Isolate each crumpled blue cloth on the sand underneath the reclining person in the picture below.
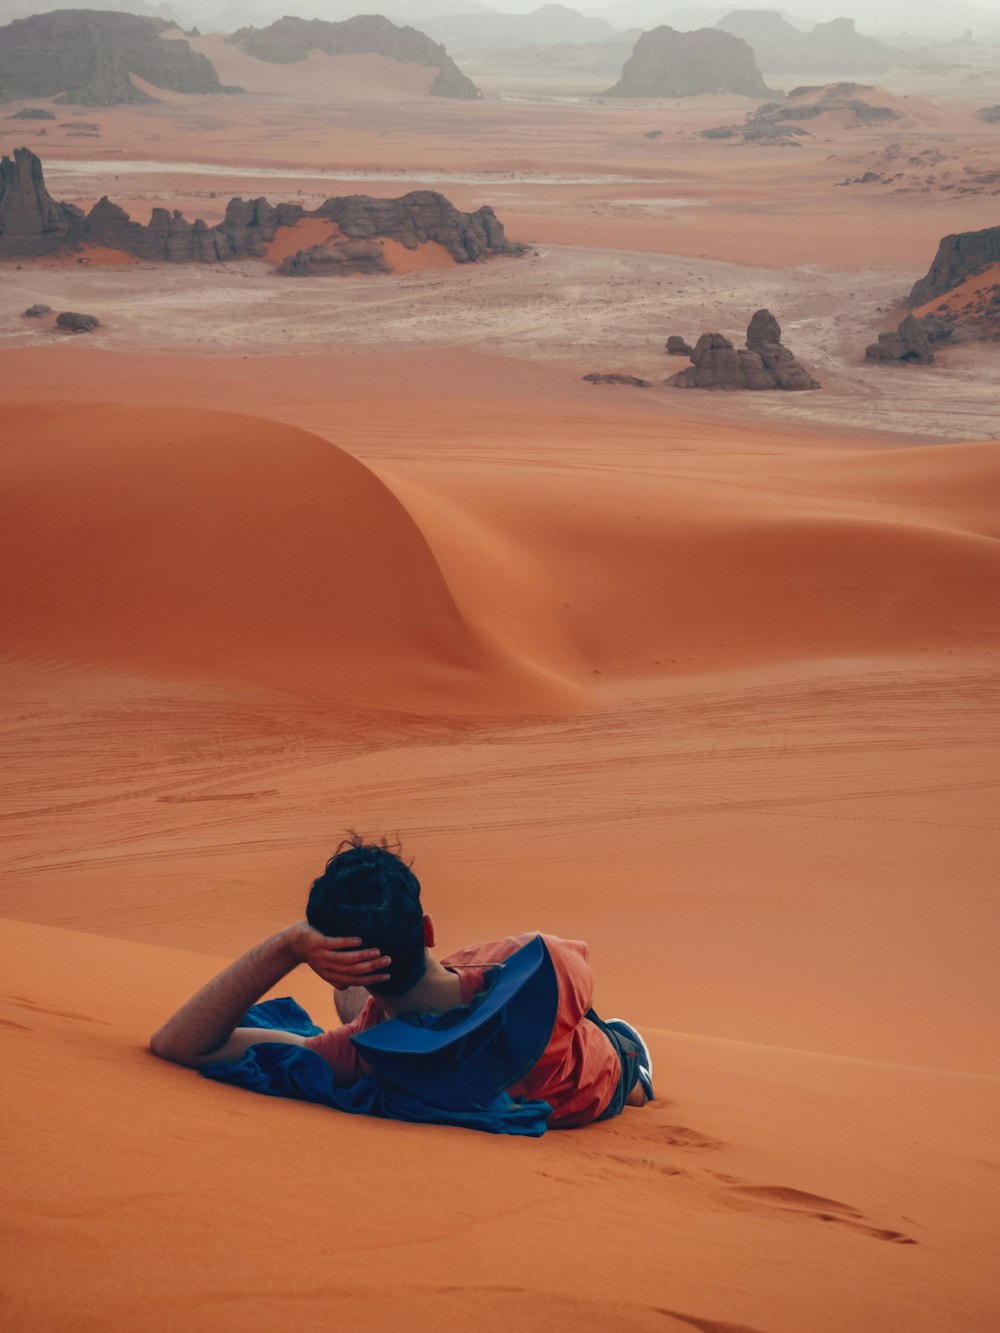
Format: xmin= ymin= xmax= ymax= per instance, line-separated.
xmin=201 ymin=997 xmax=552 ymax=1137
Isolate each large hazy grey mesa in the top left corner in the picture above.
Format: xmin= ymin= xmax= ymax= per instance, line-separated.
xmin=0 ymin=9 xmax=239 ymax=106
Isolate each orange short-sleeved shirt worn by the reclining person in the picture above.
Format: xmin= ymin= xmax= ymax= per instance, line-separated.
xmin=305 ymin=930 xmax=621 ymax=1129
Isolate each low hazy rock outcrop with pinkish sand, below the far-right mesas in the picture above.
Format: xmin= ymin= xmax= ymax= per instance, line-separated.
xmin=700 ymin=83 xmax=901 ymax=148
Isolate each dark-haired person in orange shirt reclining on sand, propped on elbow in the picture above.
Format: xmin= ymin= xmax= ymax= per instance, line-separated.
xmin=149 ymin=836 xmax=653 ymax=1129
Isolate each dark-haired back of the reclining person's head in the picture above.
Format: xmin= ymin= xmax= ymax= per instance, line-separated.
xmin=305 ymin=833 xmax=429 ymax=996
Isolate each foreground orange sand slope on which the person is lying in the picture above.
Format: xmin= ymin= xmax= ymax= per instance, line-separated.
xmin=0 ymin=921 xmax=1000 ymax=1333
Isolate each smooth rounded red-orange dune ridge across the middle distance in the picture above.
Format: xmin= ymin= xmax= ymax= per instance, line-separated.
xmin=1 ymin=404 xmax=1000 ymax=712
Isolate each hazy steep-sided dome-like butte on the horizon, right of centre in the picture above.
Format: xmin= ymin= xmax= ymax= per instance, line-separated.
xmin=607 ymin=25 xmax=773 ymax=97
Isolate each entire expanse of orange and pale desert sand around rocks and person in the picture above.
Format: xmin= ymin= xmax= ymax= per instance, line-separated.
xmin=0 ymin=39 xmax=1000 ymax=1333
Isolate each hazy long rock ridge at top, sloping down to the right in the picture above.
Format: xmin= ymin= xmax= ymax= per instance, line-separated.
xmin=227 ymin=13 xmax=483 ymax=101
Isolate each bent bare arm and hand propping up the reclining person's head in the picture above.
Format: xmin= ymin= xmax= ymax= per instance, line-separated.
xmin=149 ymin=921 xmax=391 ymax=1069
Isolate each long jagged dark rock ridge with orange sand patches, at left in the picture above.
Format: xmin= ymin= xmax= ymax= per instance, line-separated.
xmin=0 ymin=148 xmax=527 ymax=276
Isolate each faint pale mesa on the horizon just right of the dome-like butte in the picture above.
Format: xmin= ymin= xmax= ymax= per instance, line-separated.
xmin=716 ymin=9 xmax=899 ymax=75
